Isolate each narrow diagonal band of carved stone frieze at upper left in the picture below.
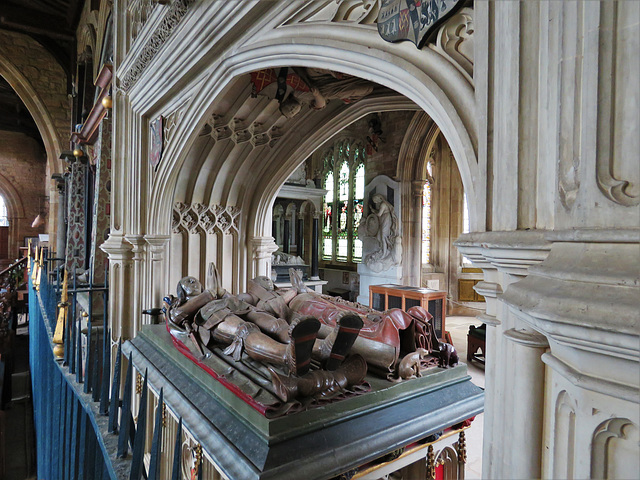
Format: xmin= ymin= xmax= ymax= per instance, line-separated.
xmin=120 ymin=0 xmax=194 ymax=92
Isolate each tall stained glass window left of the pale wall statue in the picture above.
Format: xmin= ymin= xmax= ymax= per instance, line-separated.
xmin=322 ymin=141 xmax=364 ymax=263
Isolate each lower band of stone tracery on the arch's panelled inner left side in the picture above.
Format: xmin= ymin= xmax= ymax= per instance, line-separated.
xmin=171 ymin=202 xmax=240 ymax=235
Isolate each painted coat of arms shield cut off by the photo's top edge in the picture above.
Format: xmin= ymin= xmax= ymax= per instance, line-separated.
xmin=378 ymin=0 xmax=465 ymax=48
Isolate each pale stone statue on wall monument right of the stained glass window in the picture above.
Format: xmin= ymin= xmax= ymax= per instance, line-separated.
xmin=358 ymin=193 xmax=402 ymax=272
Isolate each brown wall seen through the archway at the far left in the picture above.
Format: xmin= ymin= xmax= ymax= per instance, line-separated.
xmin=0 ymin=131 xmax=51 ymax=260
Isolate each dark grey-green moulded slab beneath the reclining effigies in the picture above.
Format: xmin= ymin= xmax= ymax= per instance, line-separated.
xmin=123 ymin=325 xmax=484 ymax=480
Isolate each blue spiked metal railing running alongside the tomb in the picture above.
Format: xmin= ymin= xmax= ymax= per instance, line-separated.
xmin=29 ymin=255 xmax=181 ymax=480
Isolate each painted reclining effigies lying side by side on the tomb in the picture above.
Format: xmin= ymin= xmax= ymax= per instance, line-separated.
xmin=165 ymin=264 xmax=457 ymax=418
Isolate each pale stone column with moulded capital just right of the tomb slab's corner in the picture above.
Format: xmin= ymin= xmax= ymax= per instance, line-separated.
xmin=455 ymin=231 xmax=550 ymax=478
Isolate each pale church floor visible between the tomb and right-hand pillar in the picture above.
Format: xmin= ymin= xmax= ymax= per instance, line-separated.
xmin=445 ymin=316 xmax=484 ymax=480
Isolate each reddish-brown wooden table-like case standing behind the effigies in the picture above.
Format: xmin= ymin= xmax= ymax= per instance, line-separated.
xmin=369 ymin=284 xmax=447 ymax=341
